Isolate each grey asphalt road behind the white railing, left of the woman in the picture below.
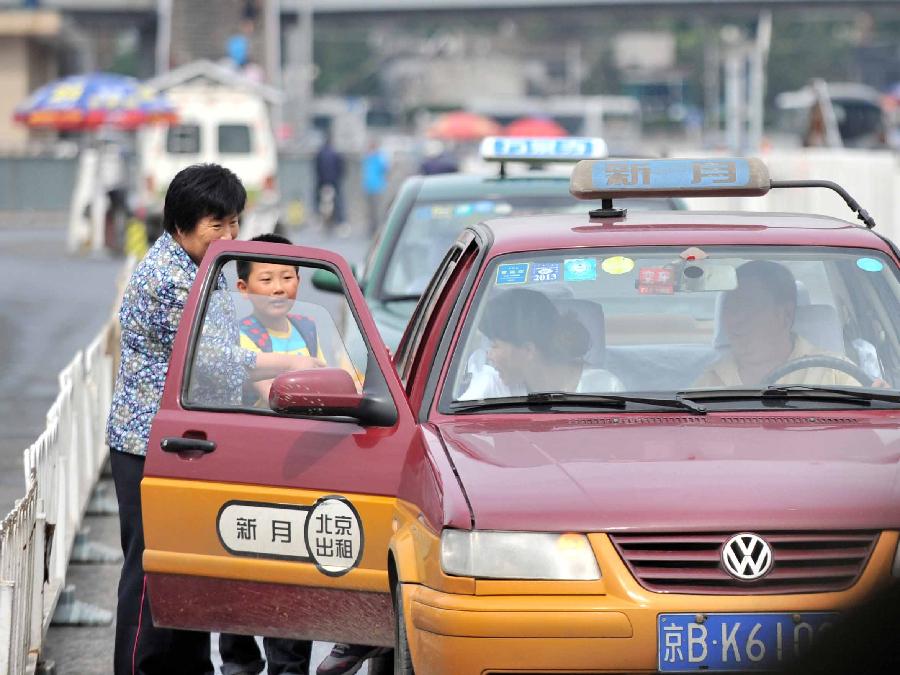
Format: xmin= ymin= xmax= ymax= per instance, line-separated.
xmin=0 ymin=216 xmax=122 ymax=517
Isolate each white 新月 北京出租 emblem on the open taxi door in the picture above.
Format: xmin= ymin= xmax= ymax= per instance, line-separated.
xmin=216 ymin=495 xmax=364 ymax=576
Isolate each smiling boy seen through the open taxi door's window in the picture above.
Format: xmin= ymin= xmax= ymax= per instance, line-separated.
xmin=237 ymin=234 xmax=325 ymax=405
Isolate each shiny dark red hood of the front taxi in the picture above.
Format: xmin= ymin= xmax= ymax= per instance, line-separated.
xmin=440 ymin=411 xmax=900 ymax=532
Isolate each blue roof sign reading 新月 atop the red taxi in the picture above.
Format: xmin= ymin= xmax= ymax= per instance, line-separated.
xmin=569 ymin=157 xmax=771 ymax=199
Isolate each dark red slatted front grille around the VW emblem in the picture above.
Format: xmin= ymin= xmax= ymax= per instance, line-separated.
xmin=609 ymin=532 xmax=878 ymax=595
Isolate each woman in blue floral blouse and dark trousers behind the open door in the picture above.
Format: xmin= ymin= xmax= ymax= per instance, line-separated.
xmin=106 ymin=164 xmax=318 ymax=675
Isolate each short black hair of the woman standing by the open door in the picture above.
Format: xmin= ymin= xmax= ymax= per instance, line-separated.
xmin=163 ymin=164 xmax=247 ymax=234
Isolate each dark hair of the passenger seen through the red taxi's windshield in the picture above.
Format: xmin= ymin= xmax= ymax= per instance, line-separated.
xmin=481 ymin=288 xmax=591 ymax=363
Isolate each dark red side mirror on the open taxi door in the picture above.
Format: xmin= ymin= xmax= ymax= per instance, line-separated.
xmin=269 ymin=368 xmax=396 ymax=426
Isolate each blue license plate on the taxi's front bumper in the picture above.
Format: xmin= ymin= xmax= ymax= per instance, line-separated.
xmin=657 ymin=612 xmax=838 ymax=673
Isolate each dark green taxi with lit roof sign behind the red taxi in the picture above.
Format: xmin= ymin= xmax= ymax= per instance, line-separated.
xmin=313 ymin=137 xmax=685 ymax=349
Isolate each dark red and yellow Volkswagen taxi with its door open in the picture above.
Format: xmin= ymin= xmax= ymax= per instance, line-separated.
xmin=142 ymin=158 xmax=900 ymax=675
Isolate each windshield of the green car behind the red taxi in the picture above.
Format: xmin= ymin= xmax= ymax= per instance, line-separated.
xmin=380 ymin=194 xmax=674 ymax=298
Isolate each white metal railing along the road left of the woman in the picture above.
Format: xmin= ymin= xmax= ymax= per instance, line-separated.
xmin=0 ymin=264 xmax=132 ymax=675
